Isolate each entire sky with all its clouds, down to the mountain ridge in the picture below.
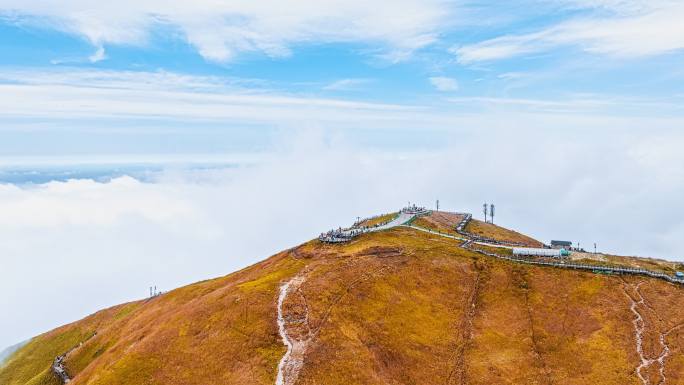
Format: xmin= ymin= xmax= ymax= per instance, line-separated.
xmin=0 ymin=0 xmax=684 ymax=347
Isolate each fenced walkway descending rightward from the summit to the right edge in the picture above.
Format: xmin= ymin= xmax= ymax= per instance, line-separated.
xmin=404 ymin=225 xmax=684 ymax=284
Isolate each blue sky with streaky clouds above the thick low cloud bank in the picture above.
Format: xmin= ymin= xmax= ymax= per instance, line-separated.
xmin=0 ymin=0 xmax=684 ymax=156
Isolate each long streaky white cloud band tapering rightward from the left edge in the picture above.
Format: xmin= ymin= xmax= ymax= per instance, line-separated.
xmin=0 ymin=69 xmax=423 ymax=125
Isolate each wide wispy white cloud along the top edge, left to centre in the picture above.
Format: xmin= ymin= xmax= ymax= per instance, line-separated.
xmin=0 ymin=0 xmax=449 ymax=61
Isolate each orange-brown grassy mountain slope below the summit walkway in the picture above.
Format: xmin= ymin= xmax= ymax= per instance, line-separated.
xmin=0 ymin=212 xmax=684 ymax=385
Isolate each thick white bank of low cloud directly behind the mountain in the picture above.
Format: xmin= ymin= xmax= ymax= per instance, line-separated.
xmin=0 ymin=127 xmax=684 ymax=346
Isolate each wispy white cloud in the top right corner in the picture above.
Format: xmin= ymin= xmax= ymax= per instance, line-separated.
xmin=451 ymin=0 xmax=684 ymax=64
